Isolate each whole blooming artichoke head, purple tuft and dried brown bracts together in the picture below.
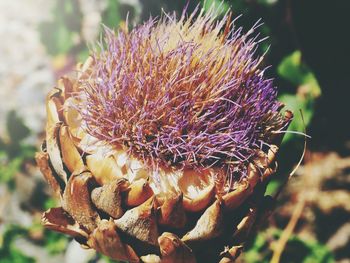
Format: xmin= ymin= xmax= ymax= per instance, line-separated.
xmin=37 ymin=4 xmax=292 ymax=262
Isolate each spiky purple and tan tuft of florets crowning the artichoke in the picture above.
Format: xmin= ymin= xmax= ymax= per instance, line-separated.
xmin=79 ymin=8 xmax=288 ymax=171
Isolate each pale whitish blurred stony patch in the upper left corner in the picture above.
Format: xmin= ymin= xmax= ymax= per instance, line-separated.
xmin=0 ymin=0 xmax=54 ymax=136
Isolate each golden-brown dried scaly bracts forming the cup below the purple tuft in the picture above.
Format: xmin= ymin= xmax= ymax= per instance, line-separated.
xmin=36 ymin=67 xmax=291 ymax=263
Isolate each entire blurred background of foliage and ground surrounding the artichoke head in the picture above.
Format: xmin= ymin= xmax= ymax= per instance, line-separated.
xmin=0 ymin=0 xmax=350 ymax=263
